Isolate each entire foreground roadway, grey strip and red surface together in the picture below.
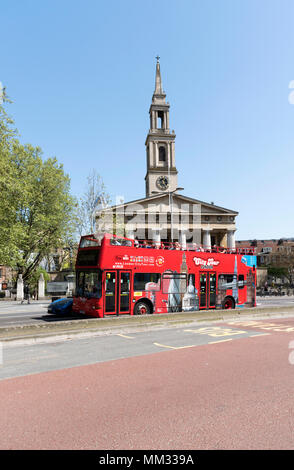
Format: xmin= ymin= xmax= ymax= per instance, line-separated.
xmin=0 ymin=317 xmax=294 ymax=450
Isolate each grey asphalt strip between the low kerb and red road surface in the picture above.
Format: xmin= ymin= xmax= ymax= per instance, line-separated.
xmin=0 ymin=323 xmax=266 ymax=379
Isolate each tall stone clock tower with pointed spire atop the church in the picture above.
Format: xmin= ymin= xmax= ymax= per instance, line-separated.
xmin=145 ymin=56 xmax=178 ymax=197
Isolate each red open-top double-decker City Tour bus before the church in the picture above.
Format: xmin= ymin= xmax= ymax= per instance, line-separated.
xmin=73 ymin=234 xmax=256 ymax=317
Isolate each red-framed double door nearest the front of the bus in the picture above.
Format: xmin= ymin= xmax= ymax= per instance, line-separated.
xmin=104 ymin=271 xmax=131 ymax=315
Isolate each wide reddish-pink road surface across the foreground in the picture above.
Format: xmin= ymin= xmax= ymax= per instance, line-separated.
xmin=0 ymin=322 xmax=294 ymax=450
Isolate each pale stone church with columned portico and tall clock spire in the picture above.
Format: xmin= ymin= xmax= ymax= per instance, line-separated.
xmin=96 ymin=57 xmax=238 ymax=248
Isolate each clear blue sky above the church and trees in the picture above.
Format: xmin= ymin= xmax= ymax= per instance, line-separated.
xmin=0 ymin=0 xmax=294 ymax=239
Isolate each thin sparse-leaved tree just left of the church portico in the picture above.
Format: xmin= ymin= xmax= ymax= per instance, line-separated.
xmin=77 ymin=169 xmax=110 ymax=236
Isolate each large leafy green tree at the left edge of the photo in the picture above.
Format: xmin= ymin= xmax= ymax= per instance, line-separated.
xmin=0 ymin=96 xmax=75 ymax=279
